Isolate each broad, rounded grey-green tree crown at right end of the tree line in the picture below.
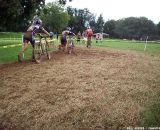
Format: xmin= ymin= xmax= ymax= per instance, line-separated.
xmin=114 ymin=17 xmax=156 ymax=39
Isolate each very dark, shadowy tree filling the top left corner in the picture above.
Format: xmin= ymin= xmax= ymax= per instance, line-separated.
xmin=0 ymin=0 xmax=45 ymax=31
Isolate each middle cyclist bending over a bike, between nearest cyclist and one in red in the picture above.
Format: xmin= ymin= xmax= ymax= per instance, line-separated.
xmin=59 ymin=27 xmax=75 ymax=51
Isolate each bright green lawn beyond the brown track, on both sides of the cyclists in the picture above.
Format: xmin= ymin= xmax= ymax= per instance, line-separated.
xmin=0 ymin=32 xmax=160 ymax=64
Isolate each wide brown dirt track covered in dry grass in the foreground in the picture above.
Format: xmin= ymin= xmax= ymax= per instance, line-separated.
xmin=0 ymin=47 xmax=160 ymax=130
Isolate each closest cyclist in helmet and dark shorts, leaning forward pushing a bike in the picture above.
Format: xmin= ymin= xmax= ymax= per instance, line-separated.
xmin=18 ymin=19 xmax=51 ymax=62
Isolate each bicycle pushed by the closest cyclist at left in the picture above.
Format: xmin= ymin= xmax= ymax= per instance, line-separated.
xmin=34 ymin=33 xmax=51 ymax=63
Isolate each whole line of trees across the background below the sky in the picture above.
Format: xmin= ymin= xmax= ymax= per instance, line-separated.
xmin=0 ymin=0 xmax=160 ymax=40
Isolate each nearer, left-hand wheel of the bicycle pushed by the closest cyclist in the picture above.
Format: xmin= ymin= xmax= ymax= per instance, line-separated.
xmin=34 ymin=42 xmax=42 ymax=63
